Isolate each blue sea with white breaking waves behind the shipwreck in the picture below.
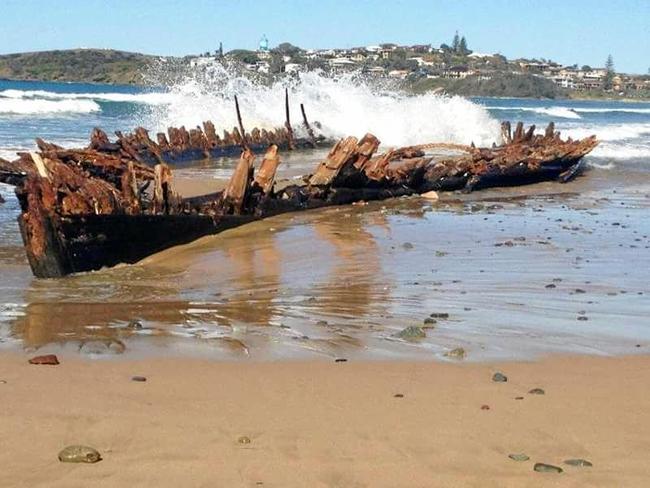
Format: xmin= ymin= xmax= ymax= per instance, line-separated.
xmin=0 ymin=75 xmax=650 ymax=167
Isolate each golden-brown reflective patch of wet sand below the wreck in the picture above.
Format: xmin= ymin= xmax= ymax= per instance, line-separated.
xmin=12 ymin=204 xmax=390 ymax=354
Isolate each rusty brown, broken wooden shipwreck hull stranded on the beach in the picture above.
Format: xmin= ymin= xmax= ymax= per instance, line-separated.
xmin=0 ymin=102 xmax=598 ymax=278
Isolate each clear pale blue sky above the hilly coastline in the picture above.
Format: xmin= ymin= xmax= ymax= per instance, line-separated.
xmin=0 ymin=0 xmax=650 ymax=73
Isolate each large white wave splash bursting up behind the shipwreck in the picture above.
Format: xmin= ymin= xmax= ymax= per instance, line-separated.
xmin=143 ymin=71 xmax=499 ymax=146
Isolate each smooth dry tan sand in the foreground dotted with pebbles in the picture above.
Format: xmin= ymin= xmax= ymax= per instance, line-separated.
xmin=0 ymin=354 xmax=650 ymax=488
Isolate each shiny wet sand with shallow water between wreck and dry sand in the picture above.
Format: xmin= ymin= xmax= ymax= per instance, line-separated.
xmin=0 ymin=168 xmax=650 ymax=360
